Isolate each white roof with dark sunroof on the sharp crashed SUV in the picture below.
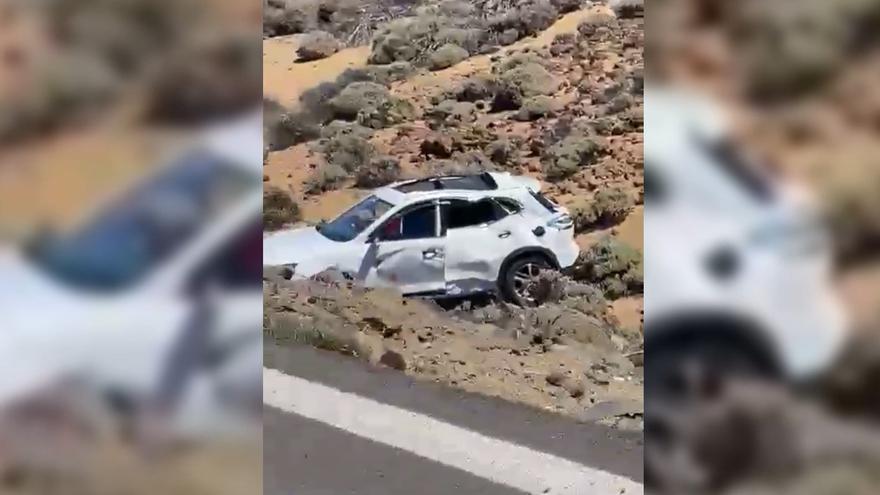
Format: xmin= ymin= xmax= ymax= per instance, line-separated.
xmin=374 ymin=172 xmax=541 ymax=205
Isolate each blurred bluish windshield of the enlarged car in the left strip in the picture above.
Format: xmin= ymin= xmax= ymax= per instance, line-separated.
xmin=29 ymin=153 xmax=259 ymax=290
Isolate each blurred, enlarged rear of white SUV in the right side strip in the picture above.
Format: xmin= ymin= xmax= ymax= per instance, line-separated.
xmin=645 ymin=89 xmax=849 ymax=493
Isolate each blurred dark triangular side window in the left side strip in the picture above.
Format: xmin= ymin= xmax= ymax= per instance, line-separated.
xmin=187 ymin=222 xmax=263 ymax=292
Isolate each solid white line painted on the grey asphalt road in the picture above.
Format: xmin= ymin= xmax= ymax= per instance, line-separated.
xmin=263 ymin=368 xmax=644 ymax=495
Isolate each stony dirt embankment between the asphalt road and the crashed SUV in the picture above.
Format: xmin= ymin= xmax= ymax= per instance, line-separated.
xmin=264 ymin=272 xmax=643 ymax=428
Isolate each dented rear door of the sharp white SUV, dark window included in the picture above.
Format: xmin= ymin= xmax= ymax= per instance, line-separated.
xmin=442 ymin=198 xmax=529 ymax=294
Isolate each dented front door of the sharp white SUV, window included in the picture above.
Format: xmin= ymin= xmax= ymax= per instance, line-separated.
xmin=364 ymin=201 xmax=446 ymax=294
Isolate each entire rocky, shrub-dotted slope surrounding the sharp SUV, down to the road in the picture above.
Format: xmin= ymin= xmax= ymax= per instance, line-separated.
xmin=264 ymin=2 xmax=643 ymax=428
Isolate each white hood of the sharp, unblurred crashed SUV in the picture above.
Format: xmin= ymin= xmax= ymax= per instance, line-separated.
xmin=263 ymin=227 xmax=345 ymax=277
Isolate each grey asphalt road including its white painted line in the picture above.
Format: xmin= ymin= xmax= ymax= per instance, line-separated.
xmin=263 ymin=343 xmax=643 ymax=495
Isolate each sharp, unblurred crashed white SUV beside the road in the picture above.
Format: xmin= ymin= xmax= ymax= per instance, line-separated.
xmin=263 ymin=172 xmax=579 ymax=305
